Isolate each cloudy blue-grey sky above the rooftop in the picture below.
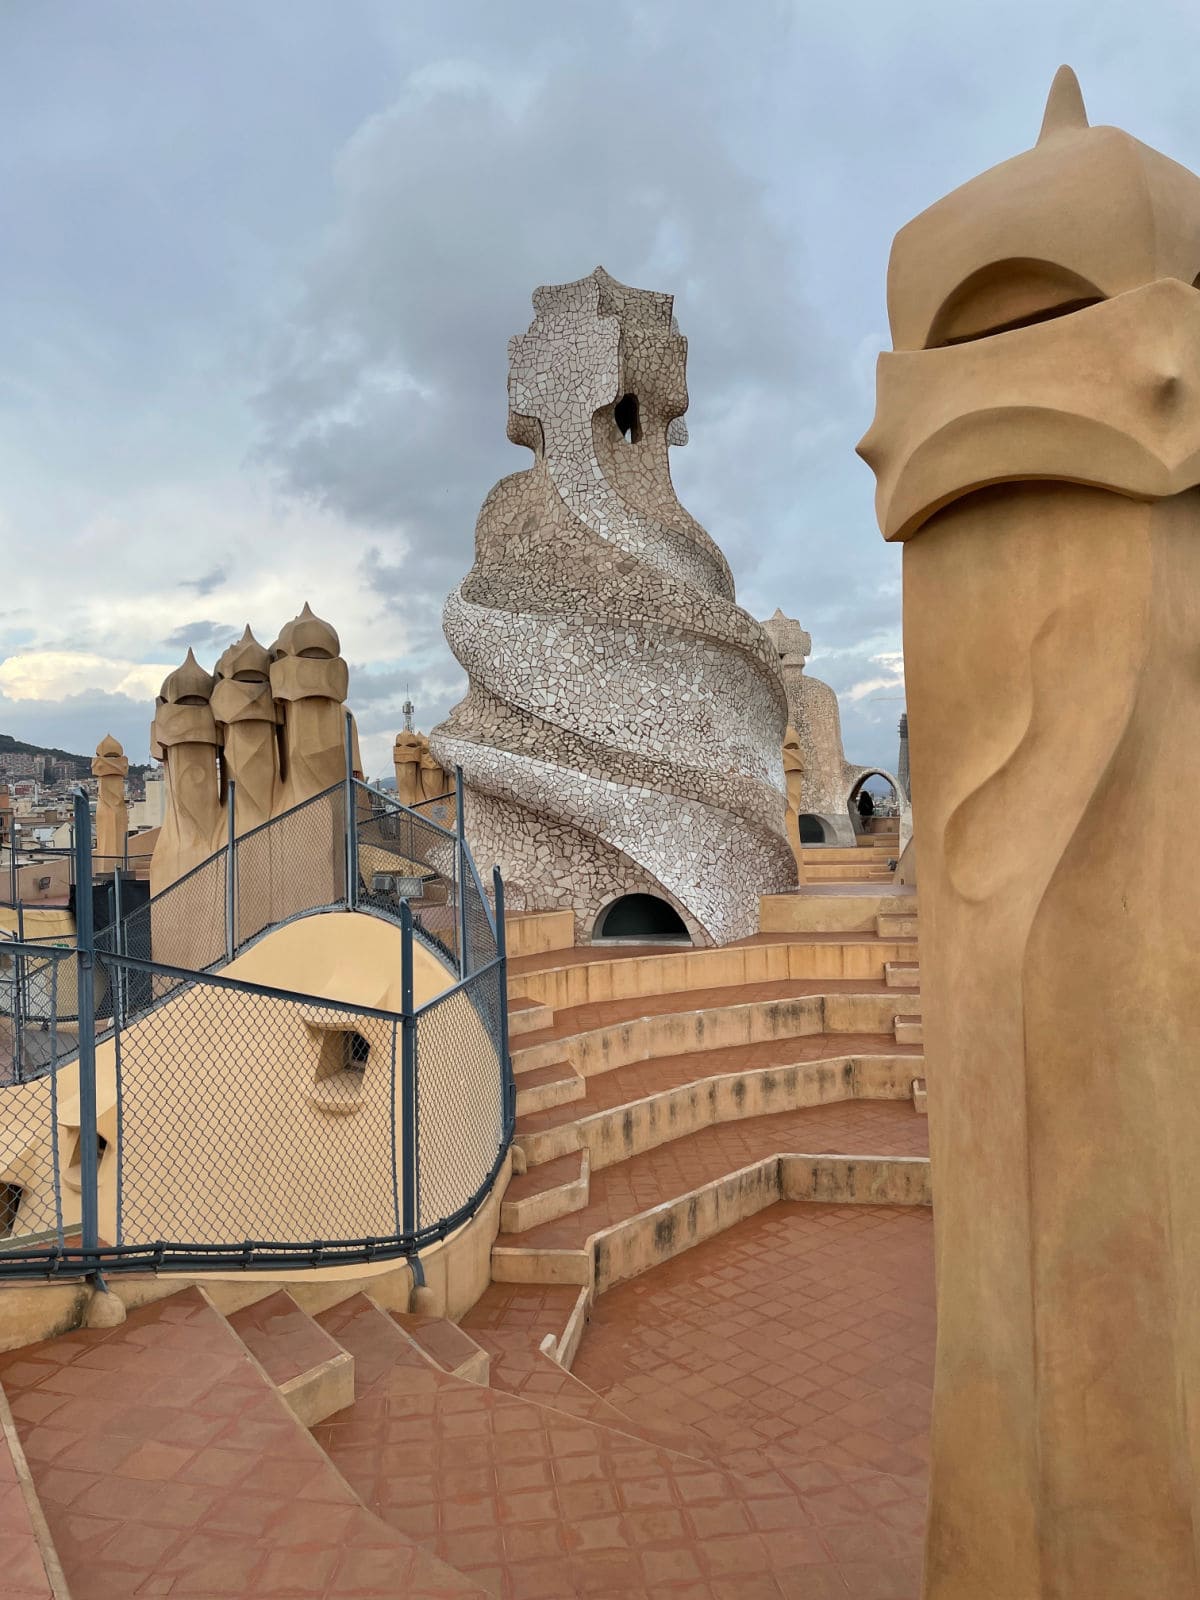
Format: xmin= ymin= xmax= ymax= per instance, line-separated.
xmin=0 ymin=0 xmax=1200 ymax=773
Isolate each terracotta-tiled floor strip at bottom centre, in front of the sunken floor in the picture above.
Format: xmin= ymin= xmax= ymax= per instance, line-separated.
xmin=314 ymin=1299 xmax=917 ymax=1600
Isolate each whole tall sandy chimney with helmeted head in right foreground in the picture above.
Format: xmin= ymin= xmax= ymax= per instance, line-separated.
xmin=861 ymin=69 xmax=1200 ymax=1600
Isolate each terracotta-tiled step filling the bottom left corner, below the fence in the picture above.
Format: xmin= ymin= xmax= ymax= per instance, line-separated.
xmin=0 ymin=1288 xmax=486 ymax=1600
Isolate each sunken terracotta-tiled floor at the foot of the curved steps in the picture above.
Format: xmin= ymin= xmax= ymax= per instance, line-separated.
xmin=574 ymin=1203 xmax=934 ymax=1484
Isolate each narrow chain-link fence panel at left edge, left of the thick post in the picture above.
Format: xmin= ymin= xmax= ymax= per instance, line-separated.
xmin=0 ymin=946 xmax=66 ymax=1254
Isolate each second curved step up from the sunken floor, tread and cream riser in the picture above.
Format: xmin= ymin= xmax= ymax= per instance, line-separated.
xmin=509 ymin=1036 xmax=917 ymax=1164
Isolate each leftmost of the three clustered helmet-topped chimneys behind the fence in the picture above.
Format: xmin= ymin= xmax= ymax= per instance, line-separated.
xmin=150 ymin=650 xmax=224 ymax=894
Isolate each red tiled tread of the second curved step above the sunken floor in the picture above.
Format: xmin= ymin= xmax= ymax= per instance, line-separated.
xmin=517 ymin=1030 xmax=922 ymax=1133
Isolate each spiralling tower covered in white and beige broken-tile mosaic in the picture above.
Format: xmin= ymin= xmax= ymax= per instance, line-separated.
xmin=432 ymin=267 xmax=795 ymax=942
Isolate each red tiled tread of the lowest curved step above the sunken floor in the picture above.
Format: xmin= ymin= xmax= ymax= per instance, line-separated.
xmin=496 ymin=1101 xmax=930 ymax=1261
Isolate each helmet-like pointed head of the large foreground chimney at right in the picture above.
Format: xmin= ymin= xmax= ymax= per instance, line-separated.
xmin=859 ymin=65 xmax=1200 ymax=539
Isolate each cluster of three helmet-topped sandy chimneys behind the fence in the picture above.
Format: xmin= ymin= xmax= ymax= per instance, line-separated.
xmin=150 ymin=605 xmax=362 ymax=920
